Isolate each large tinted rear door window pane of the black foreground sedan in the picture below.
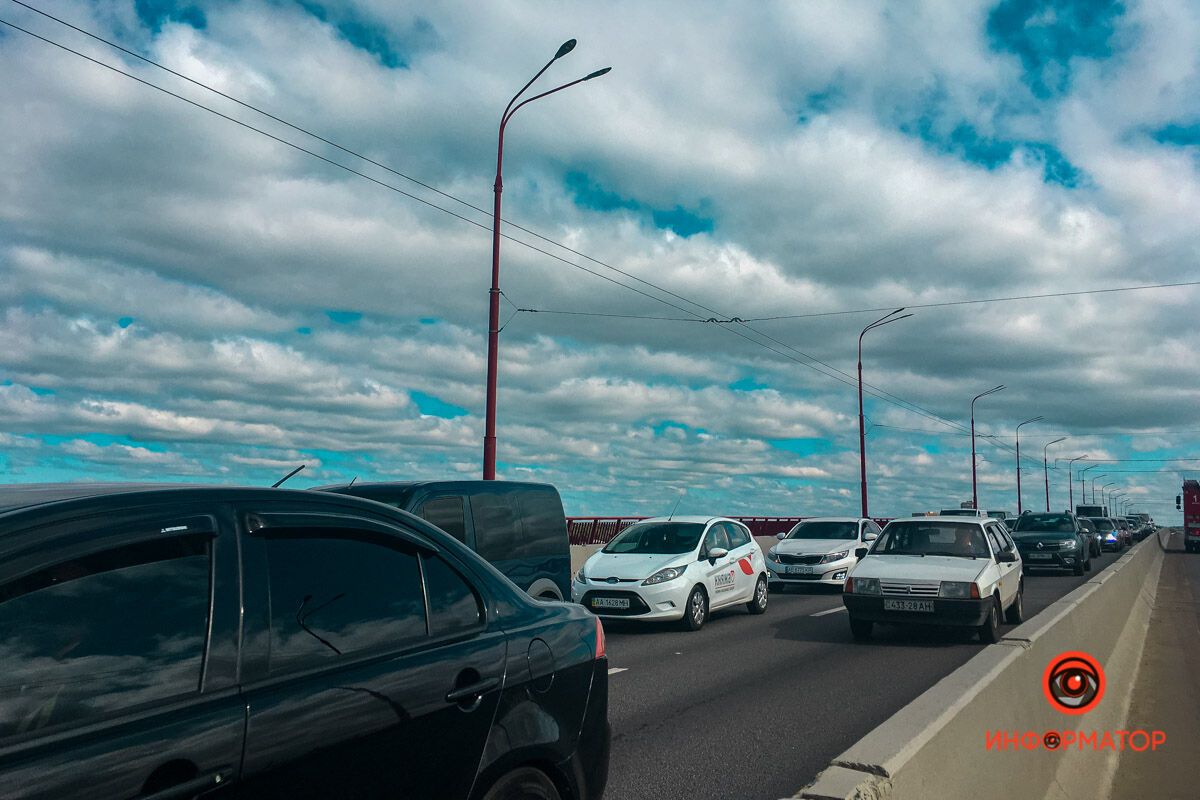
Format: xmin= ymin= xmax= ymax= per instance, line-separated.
xmin=266 ymin=529 xmax=427 ymax=674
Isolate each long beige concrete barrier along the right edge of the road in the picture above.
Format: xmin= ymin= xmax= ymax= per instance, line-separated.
xmin=796 ymin=539 xmax=1163 ymax=800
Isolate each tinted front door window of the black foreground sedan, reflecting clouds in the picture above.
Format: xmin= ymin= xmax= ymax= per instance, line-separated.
xmin=0 ymin=536 xmax=211 ymax=740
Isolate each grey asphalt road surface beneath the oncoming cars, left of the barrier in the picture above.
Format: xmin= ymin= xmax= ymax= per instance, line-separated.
xmin=605 ymin=553 xmax=1123 ymax=800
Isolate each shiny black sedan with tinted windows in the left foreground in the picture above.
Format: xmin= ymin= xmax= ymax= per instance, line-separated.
xmin=0 ymin=485 xmax=610 ymax=800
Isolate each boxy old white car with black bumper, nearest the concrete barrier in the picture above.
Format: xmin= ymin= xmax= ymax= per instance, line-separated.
xmin=842 ymin=517 xmax=1025 ymax=643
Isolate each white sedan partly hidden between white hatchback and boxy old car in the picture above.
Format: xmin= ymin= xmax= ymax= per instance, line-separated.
xmin=767 ymin=517 xmax=880 ymax=589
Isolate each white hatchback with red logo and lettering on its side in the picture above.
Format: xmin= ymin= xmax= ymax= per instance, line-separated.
xmin=571 ymin=517 xmax=767 ymax=631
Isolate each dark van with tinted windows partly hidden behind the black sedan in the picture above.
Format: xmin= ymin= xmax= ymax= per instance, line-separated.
xmin=318 ymin=481 xmax=571 ymax=600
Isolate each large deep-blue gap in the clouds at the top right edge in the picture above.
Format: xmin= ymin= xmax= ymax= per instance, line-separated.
xmin=988 ymin=0 xmax=1124 ymax=100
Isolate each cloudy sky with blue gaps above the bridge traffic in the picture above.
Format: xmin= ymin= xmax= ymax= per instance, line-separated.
xmin=0 ymin=0 xmax=1200 ymax=522
